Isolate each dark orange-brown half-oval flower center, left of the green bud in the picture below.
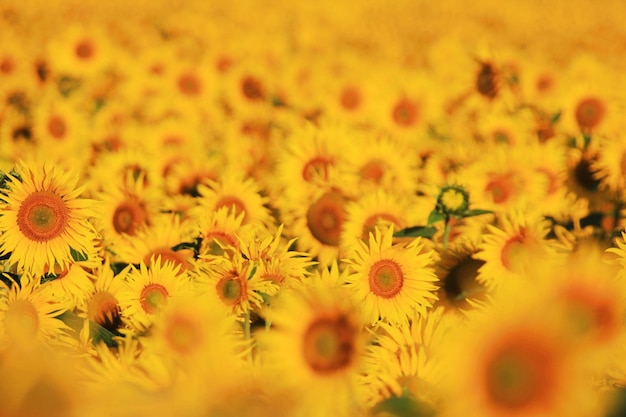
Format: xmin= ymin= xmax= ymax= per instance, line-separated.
xmin=306 ymin=192 xmax=346 ymax=246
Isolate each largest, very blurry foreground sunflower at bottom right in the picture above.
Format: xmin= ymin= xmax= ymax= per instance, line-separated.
xmin=433 ymin=285 xmax=598 ymax=417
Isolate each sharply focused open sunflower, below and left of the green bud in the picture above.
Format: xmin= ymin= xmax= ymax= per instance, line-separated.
xmin=346 ymin=227 xmax=437 ymax=324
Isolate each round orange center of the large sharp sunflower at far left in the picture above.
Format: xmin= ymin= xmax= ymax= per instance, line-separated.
xmin=17 ymin=191 xmax=69 ymax=242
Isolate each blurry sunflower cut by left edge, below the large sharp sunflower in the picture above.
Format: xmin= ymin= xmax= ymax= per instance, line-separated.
xmin=0 ymin=274 xmax=73 ymax=349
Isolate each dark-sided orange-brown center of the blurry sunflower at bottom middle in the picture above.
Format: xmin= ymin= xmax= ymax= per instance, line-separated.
xmin=303 ymin=315 xmax=358 ymax=375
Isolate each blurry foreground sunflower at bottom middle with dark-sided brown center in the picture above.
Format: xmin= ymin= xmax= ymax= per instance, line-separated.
xmin=258 ymin=286 xmax=366 ymax=416
